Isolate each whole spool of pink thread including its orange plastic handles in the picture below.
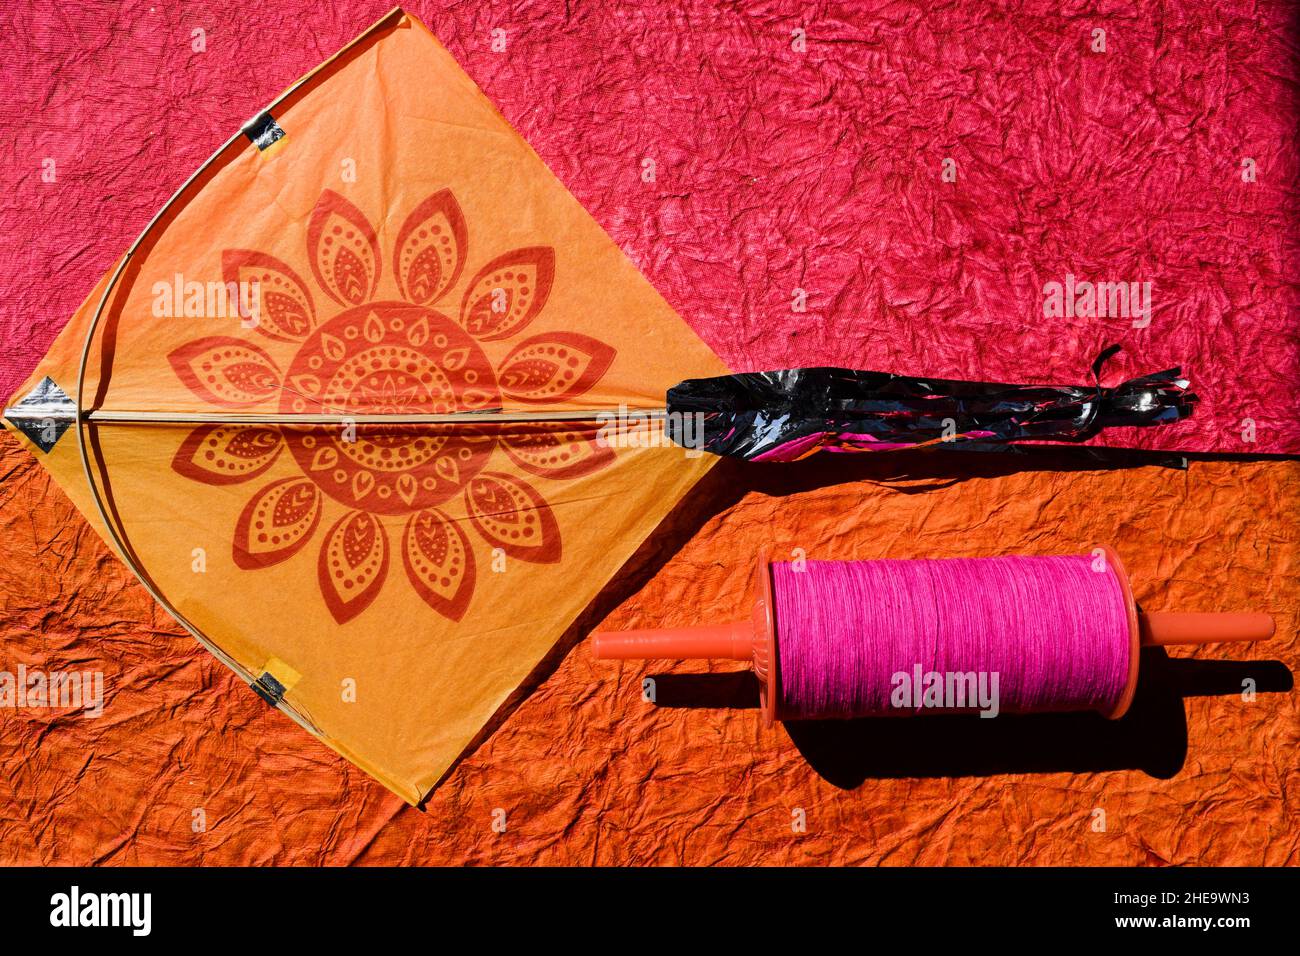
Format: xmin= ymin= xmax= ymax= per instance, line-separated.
xmin=594 ymin=548 xmax=1273 ymax=726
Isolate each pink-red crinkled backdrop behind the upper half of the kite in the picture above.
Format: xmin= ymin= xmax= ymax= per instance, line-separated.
xmin=0 ymin=0 xmax=1300 ymax=454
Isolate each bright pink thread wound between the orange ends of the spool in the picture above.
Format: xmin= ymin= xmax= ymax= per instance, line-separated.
xmin=772 ymin=555 xmax=1130 ymax=719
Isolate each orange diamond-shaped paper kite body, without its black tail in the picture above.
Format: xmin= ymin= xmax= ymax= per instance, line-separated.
xmin=2 ymin=10 xmax=728 ymax=803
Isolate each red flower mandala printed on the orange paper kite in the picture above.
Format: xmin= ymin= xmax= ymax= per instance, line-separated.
xmin=168 ymin=190 xmax=615 ymax=632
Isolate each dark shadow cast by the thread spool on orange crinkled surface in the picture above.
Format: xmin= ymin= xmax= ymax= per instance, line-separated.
xmin=654 ymin=648 xmax=1294 ymax=790
